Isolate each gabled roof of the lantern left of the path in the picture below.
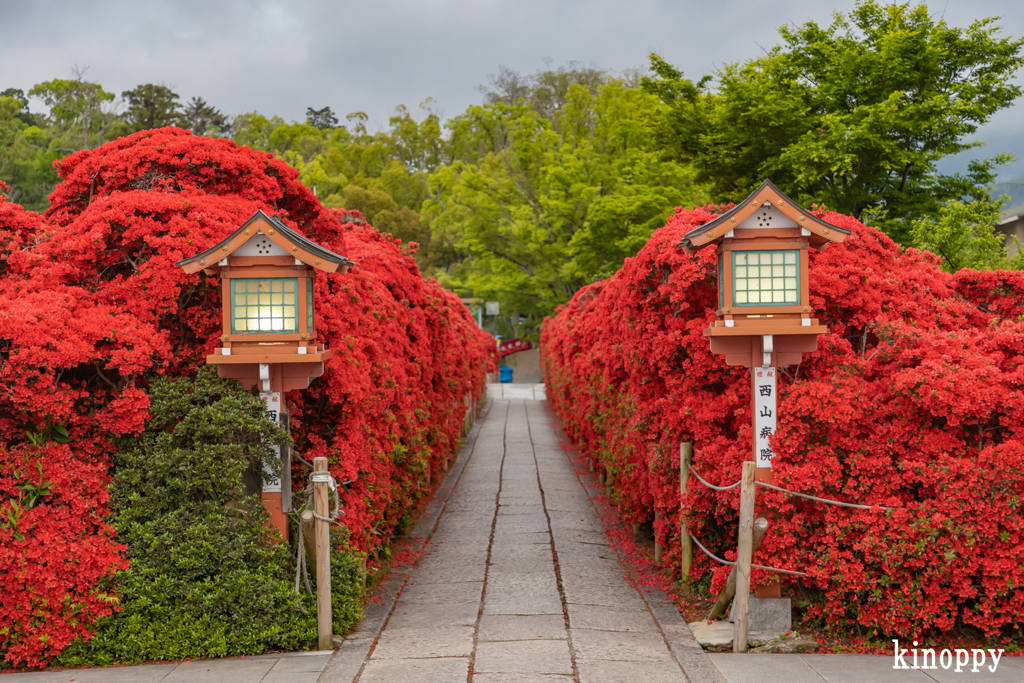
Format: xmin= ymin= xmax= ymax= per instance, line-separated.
xmin=177 ymin=211 xmax=353 ymax=273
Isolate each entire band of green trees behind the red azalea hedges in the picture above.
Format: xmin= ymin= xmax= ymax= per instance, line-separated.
xmin=0 ymin=20 xmax=1024 ymax=311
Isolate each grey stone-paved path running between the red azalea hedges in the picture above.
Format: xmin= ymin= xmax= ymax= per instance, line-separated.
xmin=321 ymin=399 xmax=721 ymax=683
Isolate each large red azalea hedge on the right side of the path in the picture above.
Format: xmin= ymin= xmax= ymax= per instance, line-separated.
xmin=541 ymin=207 xmax=1024 ymax=637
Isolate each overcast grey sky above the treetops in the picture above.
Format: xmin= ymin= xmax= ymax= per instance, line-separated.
xmin=0 ymin=0 xmax=1024 ymax=178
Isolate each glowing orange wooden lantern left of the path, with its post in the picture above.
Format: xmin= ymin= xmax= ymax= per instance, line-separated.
xmin=178 ymin=211 xmax=352 ymax=539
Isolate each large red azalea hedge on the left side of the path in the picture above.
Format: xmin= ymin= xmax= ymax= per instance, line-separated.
xmin=0 ymin=128 xmax=494 ymax=666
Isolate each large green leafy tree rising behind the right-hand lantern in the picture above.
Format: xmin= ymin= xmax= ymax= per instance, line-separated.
xmin=643 ymin=0 xmax=1024 ymax=244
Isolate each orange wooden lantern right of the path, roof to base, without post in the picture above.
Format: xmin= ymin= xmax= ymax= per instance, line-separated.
xmin=678 ymin=180 xmax=851 ymax=368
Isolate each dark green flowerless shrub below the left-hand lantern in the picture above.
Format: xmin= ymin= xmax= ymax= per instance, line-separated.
xmin=59 ymin=370 xmax=362 ymax=666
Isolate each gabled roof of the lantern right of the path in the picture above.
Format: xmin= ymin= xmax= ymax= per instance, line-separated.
xmin=677 ymin=180 xmax=851 ymax=254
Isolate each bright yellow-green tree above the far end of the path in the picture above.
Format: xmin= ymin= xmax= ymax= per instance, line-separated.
xmin=424 ymin=79 xmax=702 ymax=337
